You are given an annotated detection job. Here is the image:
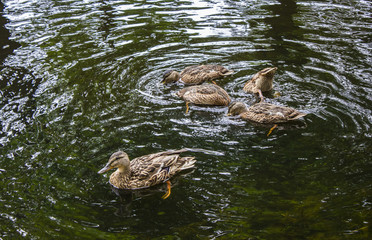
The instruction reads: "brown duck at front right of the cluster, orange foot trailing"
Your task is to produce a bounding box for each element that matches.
[227,102,307,136]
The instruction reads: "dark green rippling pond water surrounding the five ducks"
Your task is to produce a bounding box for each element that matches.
[0,0,372,239]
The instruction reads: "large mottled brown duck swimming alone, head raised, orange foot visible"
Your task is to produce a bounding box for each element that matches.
[98,149,196,199]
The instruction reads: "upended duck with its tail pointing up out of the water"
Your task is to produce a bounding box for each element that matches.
[243,67,278,102]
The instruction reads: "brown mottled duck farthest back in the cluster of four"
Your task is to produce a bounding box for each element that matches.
[162,65,234,85]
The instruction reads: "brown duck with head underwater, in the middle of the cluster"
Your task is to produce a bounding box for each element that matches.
[176,84,231,113]
